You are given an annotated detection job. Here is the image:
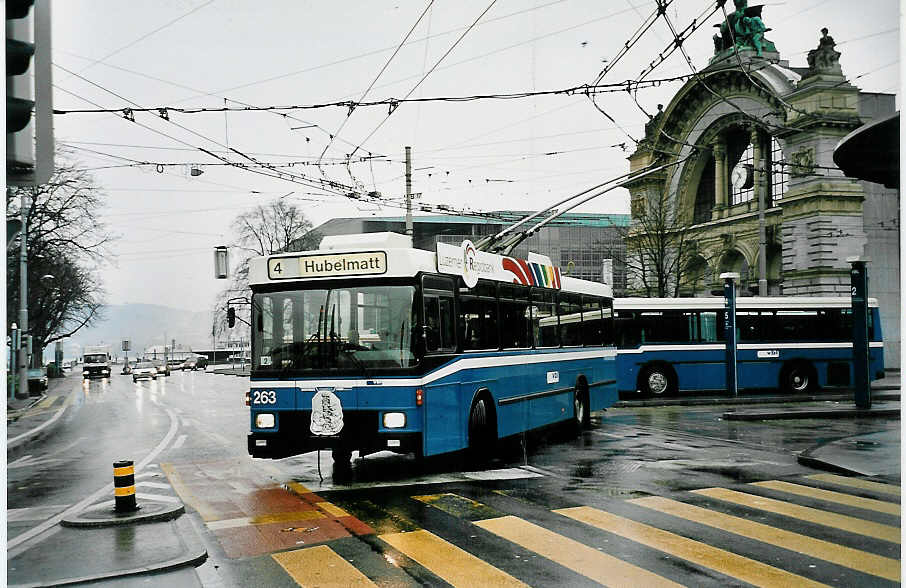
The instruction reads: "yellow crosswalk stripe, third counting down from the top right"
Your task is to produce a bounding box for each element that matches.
[692,488,900,543]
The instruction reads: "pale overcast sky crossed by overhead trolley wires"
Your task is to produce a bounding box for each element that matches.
[53,0,901,310]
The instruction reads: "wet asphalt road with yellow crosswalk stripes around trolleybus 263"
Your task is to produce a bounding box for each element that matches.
[7,372,900,586]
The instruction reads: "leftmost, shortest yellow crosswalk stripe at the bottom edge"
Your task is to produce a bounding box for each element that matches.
[271,545,377,588]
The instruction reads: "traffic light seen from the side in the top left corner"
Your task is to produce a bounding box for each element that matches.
[6,0,54,186]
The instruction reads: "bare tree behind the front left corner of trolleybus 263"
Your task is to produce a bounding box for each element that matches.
[213,199,321,336]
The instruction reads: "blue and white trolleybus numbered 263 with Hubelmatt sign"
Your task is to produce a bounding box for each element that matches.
[248,233,617,464]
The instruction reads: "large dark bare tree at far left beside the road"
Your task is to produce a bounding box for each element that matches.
[6,153,112,366]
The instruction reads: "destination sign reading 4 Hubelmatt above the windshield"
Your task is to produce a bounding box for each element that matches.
[267,251,387,280]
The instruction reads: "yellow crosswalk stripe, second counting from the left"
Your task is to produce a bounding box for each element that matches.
[380,530,526,588]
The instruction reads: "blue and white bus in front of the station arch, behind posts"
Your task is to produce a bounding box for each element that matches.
[614,296,884,397]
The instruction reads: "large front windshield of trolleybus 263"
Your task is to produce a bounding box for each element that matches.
[252,285,416,376]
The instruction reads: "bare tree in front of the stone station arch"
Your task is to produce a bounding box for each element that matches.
[623,190,697,297]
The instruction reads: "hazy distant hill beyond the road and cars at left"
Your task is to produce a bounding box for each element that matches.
[55,304,211,359]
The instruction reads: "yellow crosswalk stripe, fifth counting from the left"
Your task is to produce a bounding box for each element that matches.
[627,496,900,582]
